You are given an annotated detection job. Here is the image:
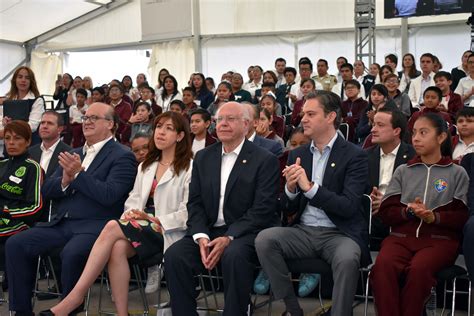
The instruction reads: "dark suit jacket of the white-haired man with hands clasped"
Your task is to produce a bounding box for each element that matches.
[187,140,280,238]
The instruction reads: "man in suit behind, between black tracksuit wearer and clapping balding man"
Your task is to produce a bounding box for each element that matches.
[29,111,71,222]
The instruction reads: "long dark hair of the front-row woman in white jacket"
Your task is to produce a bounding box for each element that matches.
[142,111,193,175]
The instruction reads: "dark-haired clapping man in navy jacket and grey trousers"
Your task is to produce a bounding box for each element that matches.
[255,91,370,316]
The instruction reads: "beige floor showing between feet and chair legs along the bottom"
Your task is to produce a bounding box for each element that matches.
[0,285,467,316]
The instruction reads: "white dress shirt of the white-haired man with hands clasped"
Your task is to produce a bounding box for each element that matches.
[193,138,245,243]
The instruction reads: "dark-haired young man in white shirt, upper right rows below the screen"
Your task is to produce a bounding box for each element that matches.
[408,53,435,108]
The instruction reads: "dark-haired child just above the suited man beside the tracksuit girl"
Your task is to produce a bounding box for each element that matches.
[356,83,388,142]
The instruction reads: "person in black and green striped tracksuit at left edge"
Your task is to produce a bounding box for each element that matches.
[0,121,44,280]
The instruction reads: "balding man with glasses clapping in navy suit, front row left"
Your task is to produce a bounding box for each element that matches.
[6,103,136,316]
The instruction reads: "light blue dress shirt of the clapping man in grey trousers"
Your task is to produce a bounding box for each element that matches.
[285,133,338,227]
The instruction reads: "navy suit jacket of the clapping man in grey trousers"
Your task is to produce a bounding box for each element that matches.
[285,135,370,266]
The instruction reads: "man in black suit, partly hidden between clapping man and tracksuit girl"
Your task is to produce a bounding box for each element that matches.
[367,108,415,250]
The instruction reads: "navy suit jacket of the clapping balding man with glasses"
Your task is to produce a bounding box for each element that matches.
[42,139,137,234]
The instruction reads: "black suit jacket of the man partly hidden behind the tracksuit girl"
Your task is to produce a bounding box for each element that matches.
[366,142,416,194]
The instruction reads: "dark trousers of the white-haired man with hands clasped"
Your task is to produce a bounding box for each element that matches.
[164,227,258,316]
